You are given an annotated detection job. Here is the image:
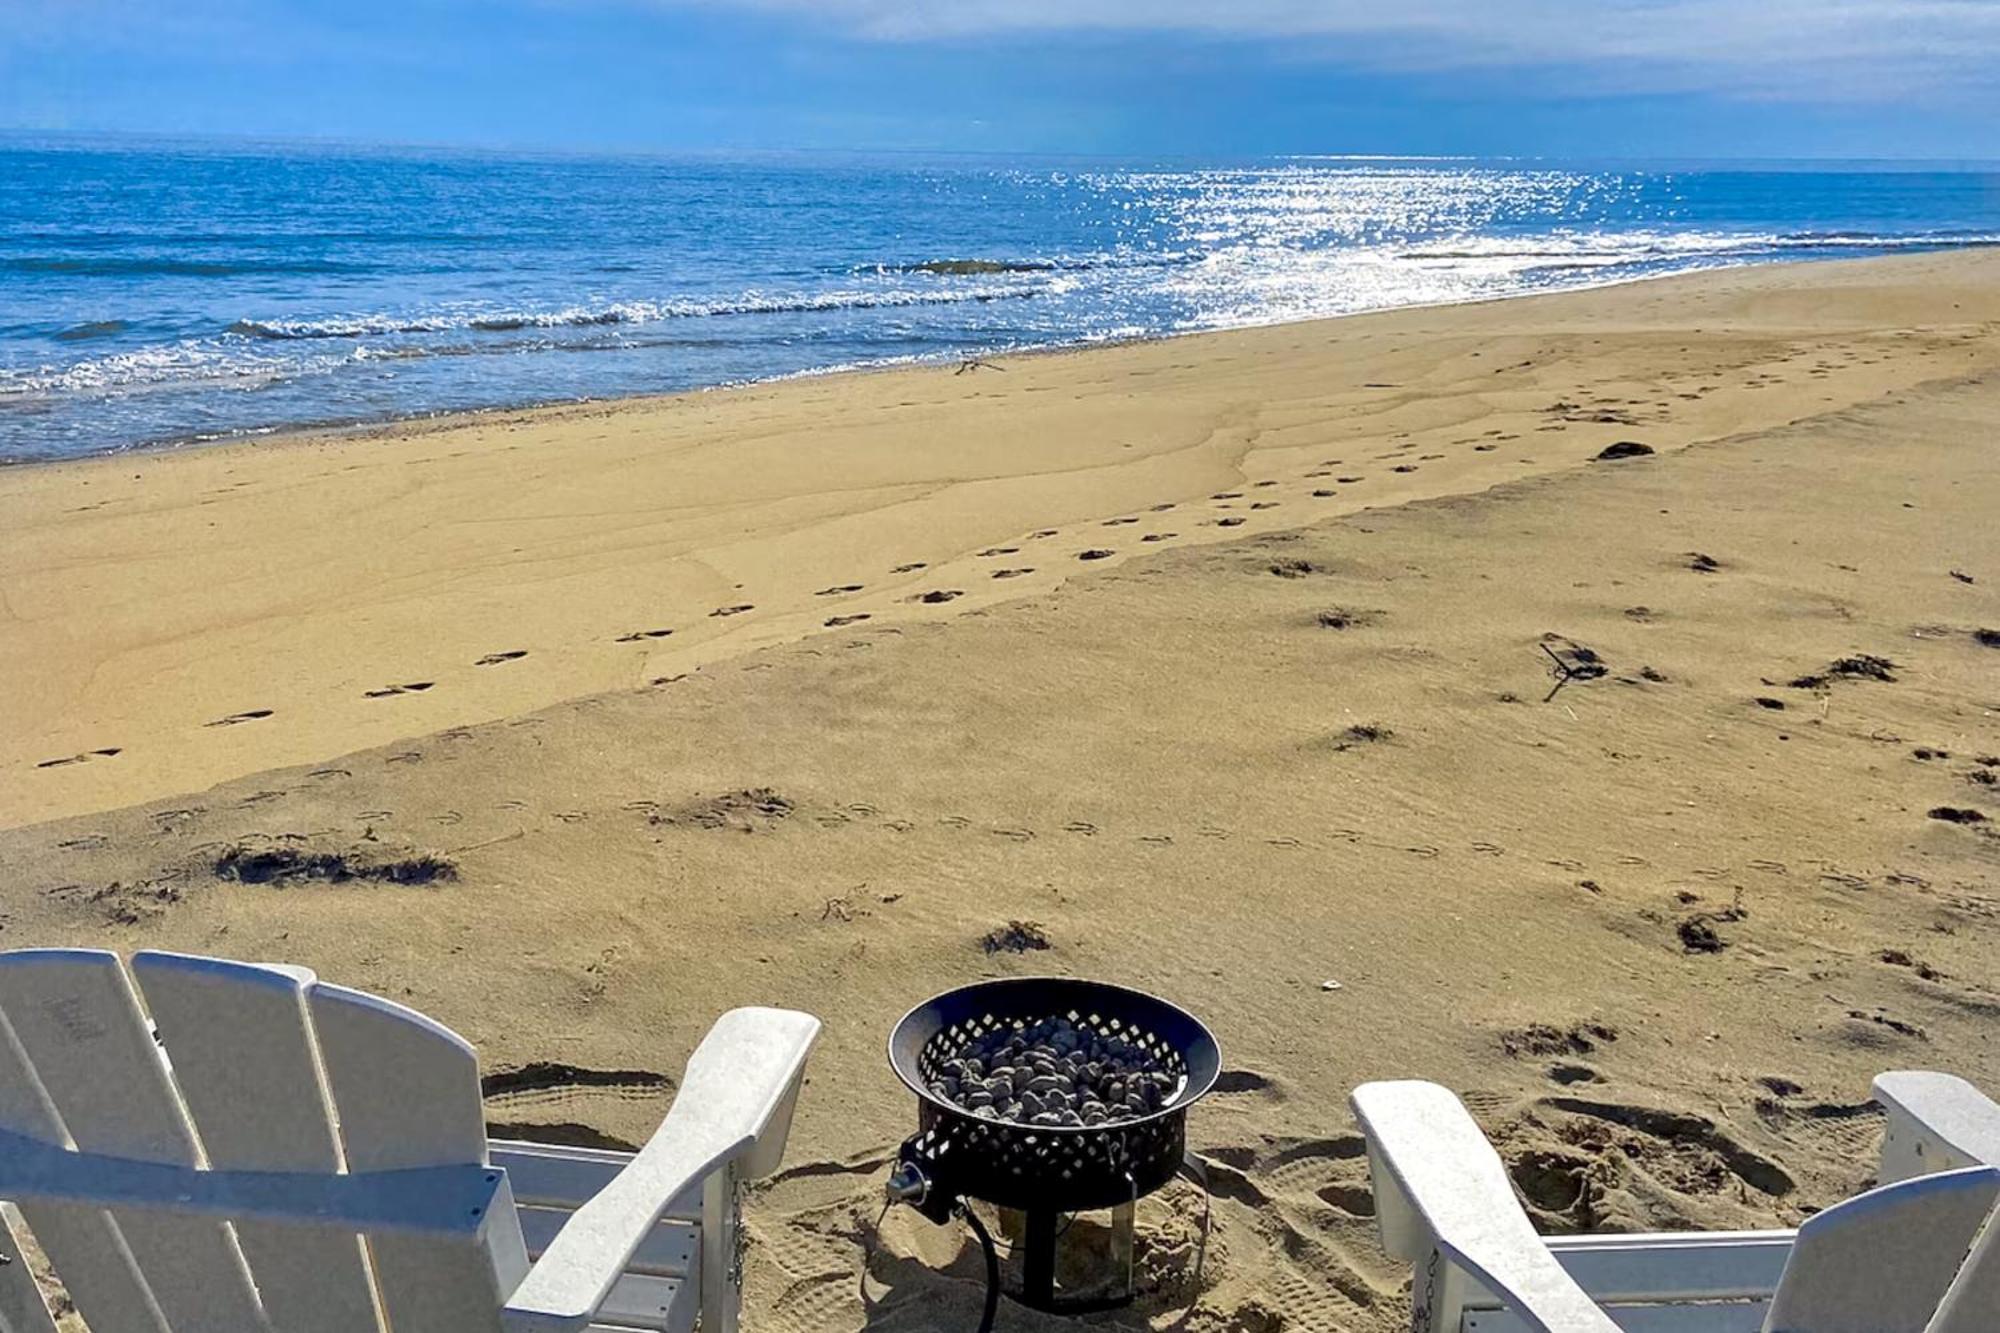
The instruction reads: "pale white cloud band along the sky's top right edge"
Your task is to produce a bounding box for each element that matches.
[666,0,2000,100]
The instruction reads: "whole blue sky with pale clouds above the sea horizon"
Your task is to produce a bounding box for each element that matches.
[0,0,2000,158]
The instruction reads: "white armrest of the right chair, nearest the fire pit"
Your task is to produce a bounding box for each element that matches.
[1352,1081,1618,1333]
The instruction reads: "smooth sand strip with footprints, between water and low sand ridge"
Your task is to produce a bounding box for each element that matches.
[0,250,2000,827]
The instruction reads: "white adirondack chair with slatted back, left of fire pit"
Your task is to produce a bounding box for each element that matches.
[0,949,820,1333]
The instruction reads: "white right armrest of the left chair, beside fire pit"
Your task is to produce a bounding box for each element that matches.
[502,1009,820,1333]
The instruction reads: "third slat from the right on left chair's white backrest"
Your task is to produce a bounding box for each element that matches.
[0,949,268,1333]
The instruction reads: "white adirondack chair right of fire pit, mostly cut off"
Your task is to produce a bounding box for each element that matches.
[1352,1073,2000,1333]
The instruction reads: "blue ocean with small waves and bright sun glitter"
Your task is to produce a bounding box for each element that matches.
[0,136,2000,462]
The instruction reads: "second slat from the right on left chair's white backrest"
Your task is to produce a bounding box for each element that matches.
[132,953,380,1333]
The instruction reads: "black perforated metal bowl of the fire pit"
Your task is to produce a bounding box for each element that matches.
[888,964,1222,1221]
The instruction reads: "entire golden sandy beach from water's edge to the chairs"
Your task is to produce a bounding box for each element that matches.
[0,254,2000,1333]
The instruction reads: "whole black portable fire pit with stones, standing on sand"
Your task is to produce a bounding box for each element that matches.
[888,977,1222,1323]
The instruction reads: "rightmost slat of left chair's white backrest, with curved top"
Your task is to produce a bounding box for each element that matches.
[310,985,528,1333]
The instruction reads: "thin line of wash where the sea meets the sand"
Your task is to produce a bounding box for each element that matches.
[0,240,2000,470]
